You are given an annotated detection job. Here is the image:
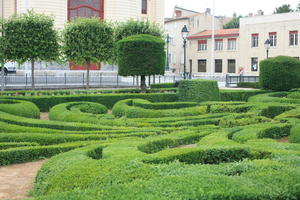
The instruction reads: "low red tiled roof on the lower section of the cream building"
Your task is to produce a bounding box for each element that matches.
[188,29,240,39]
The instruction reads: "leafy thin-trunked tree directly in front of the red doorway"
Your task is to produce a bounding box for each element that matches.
[63,18,114,88]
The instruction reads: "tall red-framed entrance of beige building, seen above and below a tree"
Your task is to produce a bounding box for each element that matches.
[68,0,104,70]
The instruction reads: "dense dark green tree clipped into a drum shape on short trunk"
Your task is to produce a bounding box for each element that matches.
[117,34,166,89]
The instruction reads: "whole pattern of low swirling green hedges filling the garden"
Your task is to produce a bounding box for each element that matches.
[0,82,300,200]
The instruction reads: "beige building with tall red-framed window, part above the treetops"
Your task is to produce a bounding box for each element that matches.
[0,0,164,28]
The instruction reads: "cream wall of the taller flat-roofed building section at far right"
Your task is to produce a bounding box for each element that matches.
[239,12,300,75]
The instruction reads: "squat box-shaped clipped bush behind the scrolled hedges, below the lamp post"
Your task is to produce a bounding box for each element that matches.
[178,79,220,102]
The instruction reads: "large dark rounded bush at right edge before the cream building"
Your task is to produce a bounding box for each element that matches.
[260,56,300,91]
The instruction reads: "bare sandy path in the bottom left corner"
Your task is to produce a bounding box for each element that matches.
[0,161,45,199]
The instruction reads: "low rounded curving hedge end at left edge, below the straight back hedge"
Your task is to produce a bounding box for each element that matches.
[0,99,40,119]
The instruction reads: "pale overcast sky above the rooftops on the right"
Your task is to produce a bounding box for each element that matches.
[165,0,300,17]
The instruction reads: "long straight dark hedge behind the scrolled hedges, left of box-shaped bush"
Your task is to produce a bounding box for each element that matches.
[2,93,178,112]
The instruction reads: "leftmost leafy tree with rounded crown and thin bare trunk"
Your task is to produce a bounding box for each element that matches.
[3,11,59,89]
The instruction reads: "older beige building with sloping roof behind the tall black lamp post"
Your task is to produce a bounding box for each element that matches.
[165,6,232,73]
